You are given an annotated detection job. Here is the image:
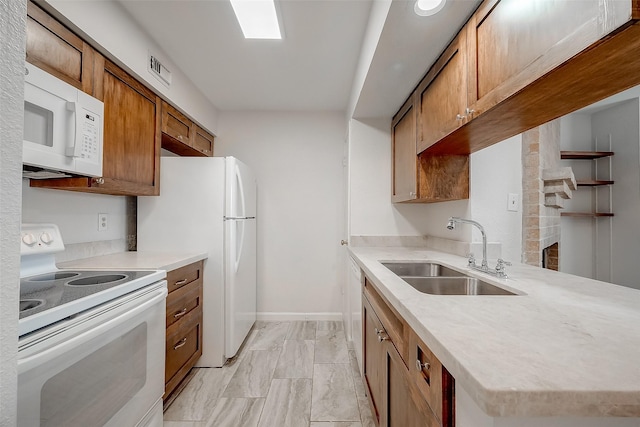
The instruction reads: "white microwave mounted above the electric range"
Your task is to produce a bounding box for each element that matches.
[22,63,104,179]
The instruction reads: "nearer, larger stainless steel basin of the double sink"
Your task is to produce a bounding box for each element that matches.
[402,277,516,295]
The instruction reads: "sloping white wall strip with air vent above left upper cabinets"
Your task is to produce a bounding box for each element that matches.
[47,0,218,134]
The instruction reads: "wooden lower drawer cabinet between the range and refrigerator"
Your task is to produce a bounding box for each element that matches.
[163,261,203,401]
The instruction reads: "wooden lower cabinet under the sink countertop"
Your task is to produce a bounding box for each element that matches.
[362,279,455,427]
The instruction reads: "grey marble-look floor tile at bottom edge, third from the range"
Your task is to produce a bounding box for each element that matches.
[259,378,312,427]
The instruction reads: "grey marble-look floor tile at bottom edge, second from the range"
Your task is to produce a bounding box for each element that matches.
[206,397,264,427]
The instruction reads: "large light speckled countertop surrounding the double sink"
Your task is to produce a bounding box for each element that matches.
[350,247,640,417]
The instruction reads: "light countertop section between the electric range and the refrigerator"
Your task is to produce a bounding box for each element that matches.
[57,252,207,271]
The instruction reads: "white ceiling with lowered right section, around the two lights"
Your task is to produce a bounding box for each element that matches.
[119,0,480,118]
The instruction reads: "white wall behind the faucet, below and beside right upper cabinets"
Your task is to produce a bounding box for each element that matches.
[349,119,522,262]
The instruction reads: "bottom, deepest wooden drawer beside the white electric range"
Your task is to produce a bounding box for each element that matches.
[164,310,202,390]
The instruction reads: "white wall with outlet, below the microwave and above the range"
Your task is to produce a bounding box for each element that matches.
[22,179,127,244]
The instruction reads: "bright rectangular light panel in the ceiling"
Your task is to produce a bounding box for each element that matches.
[230,0,282,39]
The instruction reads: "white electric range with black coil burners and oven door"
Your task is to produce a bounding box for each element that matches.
[18,224,167,427]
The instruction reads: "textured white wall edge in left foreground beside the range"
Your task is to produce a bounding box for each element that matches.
[0,0,27,426]
